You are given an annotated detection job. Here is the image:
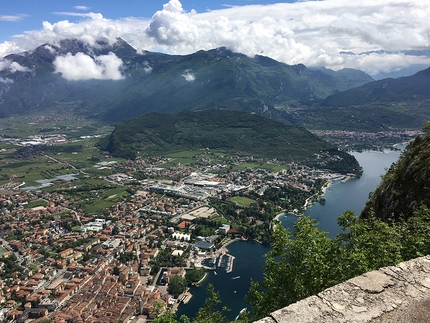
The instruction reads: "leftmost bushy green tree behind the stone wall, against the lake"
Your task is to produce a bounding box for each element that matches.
[247,216,336,318]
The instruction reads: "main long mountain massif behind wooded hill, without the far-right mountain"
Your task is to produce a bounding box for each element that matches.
[0,39,372,122]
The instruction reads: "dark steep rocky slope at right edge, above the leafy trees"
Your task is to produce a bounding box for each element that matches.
[361,130,430,221]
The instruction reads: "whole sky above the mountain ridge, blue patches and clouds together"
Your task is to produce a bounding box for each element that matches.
[0,0,430,77]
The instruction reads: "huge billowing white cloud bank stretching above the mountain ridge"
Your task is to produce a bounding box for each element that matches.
[0,0,430,73]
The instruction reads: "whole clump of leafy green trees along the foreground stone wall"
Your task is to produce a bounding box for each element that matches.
[247,207,430,319]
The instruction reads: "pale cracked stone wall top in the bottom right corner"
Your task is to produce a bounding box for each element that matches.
[258,256,430,323]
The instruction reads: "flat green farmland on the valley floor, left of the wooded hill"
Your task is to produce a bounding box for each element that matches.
[0,117,122,186]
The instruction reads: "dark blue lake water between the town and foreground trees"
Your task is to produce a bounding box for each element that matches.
[177,146,404,320]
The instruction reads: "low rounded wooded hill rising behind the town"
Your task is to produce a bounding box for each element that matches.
[100,109,360,173]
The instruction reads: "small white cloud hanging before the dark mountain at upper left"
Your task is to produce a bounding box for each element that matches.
[54,53,124,81]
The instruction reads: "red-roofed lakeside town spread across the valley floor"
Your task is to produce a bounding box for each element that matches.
[0,123,412,323]
